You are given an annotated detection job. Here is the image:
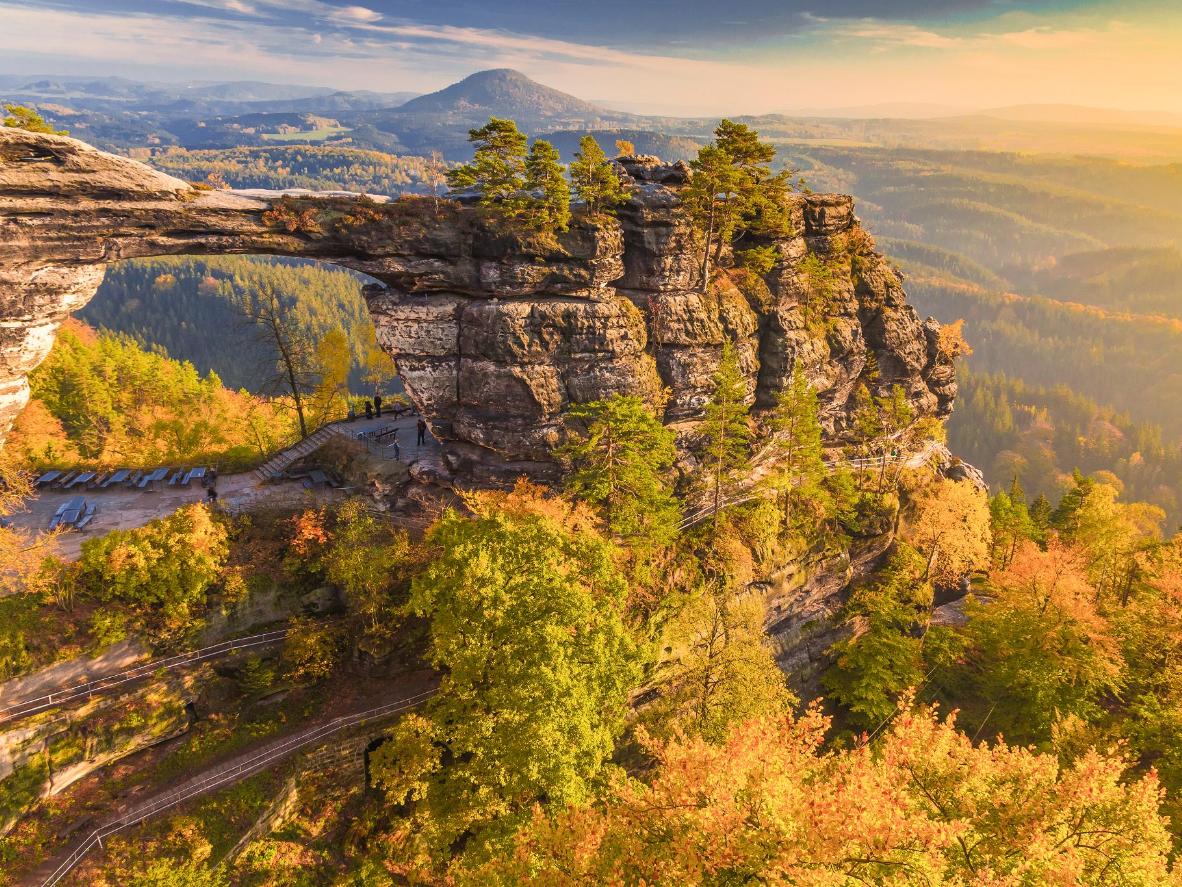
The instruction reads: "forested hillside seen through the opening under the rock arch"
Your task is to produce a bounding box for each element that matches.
[79,255,397,391]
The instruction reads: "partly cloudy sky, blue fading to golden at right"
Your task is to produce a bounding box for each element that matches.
[0,0,1182,115]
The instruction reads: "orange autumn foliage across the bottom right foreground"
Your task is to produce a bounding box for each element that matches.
[456,706,1178,887]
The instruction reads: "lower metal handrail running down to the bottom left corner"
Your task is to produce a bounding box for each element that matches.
[44,689,436,887]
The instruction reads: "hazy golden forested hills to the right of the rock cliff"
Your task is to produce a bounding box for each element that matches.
[782,144,1182,522]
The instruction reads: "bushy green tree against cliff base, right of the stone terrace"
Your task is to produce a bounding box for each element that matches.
[559,394,681,562]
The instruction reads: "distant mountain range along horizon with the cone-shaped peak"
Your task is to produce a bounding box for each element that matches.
[0,69,1182,162]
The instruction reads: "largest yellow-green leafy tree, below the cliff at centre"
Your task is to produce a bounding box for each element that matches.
[385,485,639,861]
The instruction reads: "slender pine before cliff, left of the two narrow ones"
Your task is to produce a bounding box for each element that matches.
[701,342,751,522]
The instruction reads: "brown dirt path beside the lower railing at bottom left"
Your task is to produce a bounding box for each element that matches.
[18,671,437,887]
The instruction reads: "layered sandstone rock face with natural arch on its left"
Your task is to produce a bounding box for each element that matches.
[0,128,956,484]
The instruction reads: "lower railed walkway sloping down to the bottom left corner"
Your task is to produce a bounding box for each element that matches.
[32,688,435,887]
